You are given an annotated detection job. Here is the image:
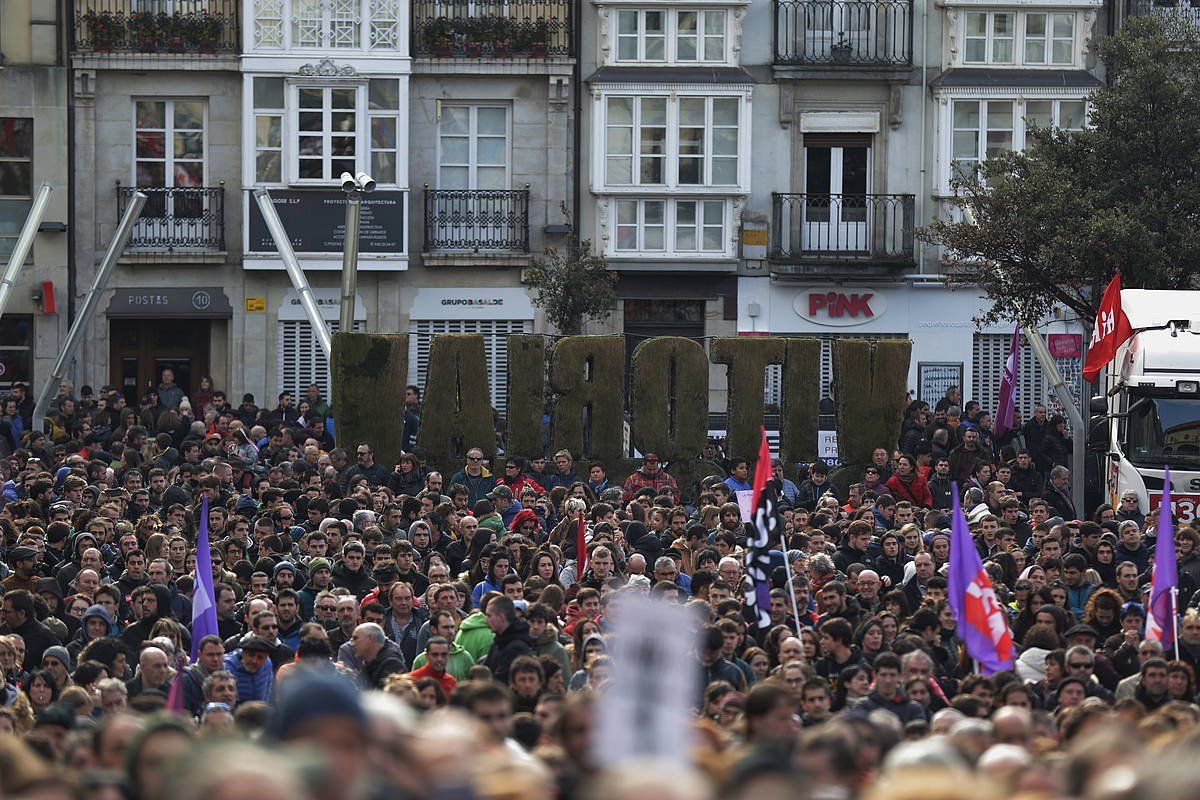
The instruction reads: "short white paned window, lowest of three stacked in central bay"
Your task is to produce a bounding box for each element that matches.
[613,199,728,255]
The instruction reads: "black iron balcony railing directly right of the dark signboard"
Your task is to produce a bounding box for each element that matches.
[425,185,529,253]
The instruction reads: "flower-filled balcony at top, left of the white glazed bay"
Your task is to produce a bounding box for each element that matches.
[71,0,240,55]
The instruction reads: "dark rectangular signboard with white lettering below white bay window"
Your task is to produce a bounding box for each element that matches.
[250,190,404,254]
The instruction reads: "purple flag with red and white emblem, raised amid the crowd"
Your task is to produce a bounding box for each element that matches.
[947,483,1013,675]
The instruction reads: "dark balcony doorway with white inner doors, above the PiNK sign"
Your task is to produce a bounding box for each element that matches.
[804,133,871,252]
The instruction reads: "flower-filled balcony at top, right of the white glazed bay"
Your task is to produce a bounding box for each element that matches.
[412,0,575,61]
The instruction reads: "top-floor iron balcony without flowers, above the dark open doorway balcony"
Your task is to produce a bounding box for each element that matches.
[774,0,912,71]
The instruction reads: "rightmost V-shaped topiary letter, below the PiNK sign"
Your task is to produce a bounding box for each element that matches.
[833,338,912,467]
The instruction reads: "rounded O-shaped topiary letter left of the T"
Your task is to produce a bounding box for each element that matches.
[630,336,708,486]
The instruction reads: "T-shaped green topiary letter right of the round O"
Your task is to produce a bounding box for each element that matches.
[712,337,785,461]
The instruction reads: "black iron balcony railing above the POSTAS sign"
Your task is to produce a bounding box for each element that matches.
[116,186,224,253]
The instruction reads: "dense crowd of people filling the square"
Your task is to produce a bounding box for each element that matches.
[0,369,1200,800]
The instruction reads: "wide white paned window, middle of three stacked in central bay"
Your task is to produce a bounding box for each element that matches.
[605,96,740,187]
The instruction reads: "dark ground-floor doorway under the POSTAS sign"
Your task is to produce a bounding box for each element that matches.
[108,319,212,405]
